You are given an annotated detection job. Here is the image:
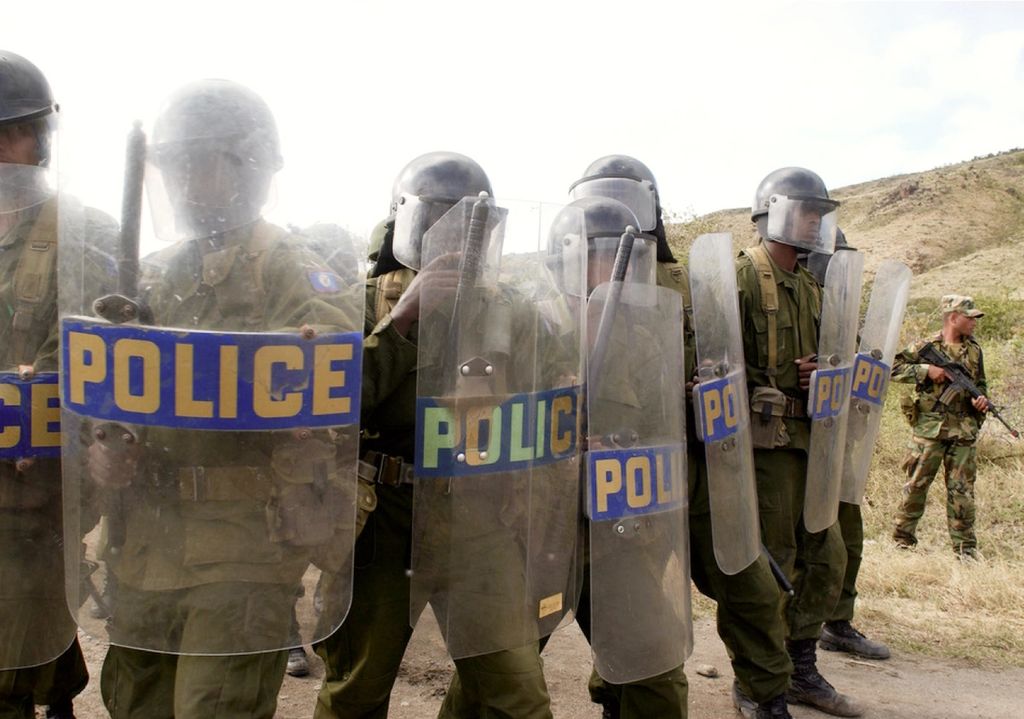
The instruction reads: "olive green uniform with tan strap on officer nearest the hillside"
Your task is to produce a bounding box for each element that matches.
[736,246,846,640]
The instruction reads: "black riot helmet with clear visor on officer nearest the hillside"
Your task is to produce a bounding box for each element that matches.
[751,167,839,255]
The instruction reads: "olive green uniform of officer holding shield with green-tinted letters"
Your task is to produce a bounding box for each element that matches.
[314,269,551,719]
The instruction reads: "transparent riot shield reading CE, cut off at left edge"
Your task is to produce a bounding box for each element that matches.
[0,163,75,670]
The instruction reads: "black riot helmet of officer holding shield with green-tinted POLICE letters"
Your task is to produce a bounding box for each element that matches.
[387,152,492,271]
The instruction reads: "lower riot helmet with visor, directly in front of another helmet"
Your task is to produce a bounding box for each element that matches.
[548,196,656,297]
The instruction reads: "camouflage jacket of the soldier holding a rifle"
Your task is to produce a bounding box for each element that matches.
[892,333,988,443]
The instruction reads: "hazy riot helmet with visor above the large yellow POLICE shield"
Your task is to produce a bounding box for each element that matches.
[146,80,283,240]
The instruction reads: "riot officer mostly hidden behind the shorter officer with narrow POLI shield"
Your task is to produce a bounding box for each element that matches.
[570,155,793,719]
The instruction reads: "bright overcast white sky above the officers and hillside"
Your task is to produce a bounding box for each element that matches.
[3,0,1024,240]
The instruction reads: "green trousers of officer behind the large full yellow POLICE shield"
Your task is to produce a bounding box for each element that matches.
[99,582,295,719]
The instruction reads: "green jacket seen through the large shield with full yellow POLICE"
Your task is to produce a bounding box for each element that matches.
[115,220,358,591]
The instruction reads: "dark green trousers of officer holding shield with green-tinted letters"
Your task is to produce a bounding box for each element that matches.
[313,484,551,719]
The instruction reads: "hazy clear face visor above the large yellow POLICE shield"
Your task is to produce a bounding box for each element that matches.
[145,141,273,242]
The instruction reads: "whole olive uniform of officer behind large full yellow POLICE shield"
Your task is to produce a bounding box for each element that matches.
[101,220,357,719]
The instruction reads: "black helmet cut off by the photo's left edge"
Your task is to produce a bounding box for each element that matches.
[0,50,59,165]
